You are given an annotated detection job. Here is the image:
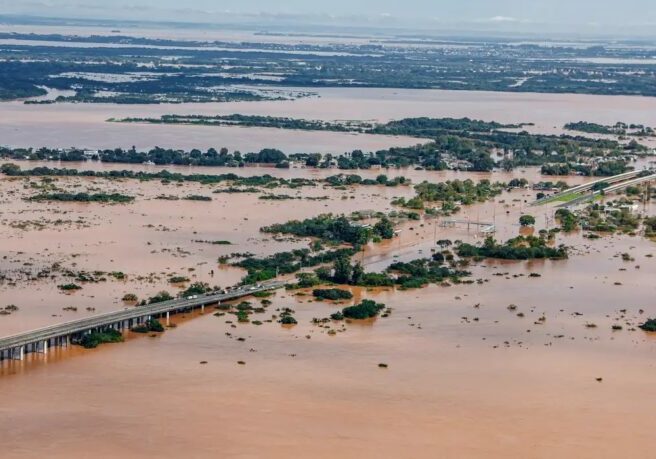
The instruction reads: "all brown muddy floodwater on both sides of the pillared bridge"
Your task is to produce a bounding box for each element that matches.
[0,163,656,458]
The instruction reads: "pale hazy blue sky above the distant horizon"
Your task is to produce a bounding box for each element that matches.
[0,0,656,36]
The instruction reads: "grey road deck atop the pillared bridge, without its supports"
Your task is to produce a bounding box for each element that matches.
[0,282,285,352]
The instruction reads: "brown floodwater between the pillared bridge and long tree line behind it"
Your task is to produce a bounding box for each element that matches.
[0,162,560,335]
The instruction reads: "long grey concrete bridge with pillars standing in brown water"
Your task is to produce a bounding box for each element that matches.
[0,281,285,360]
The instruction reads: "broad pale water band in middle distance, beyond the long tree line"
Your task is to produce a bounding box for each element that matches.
[0,88,656,154]
